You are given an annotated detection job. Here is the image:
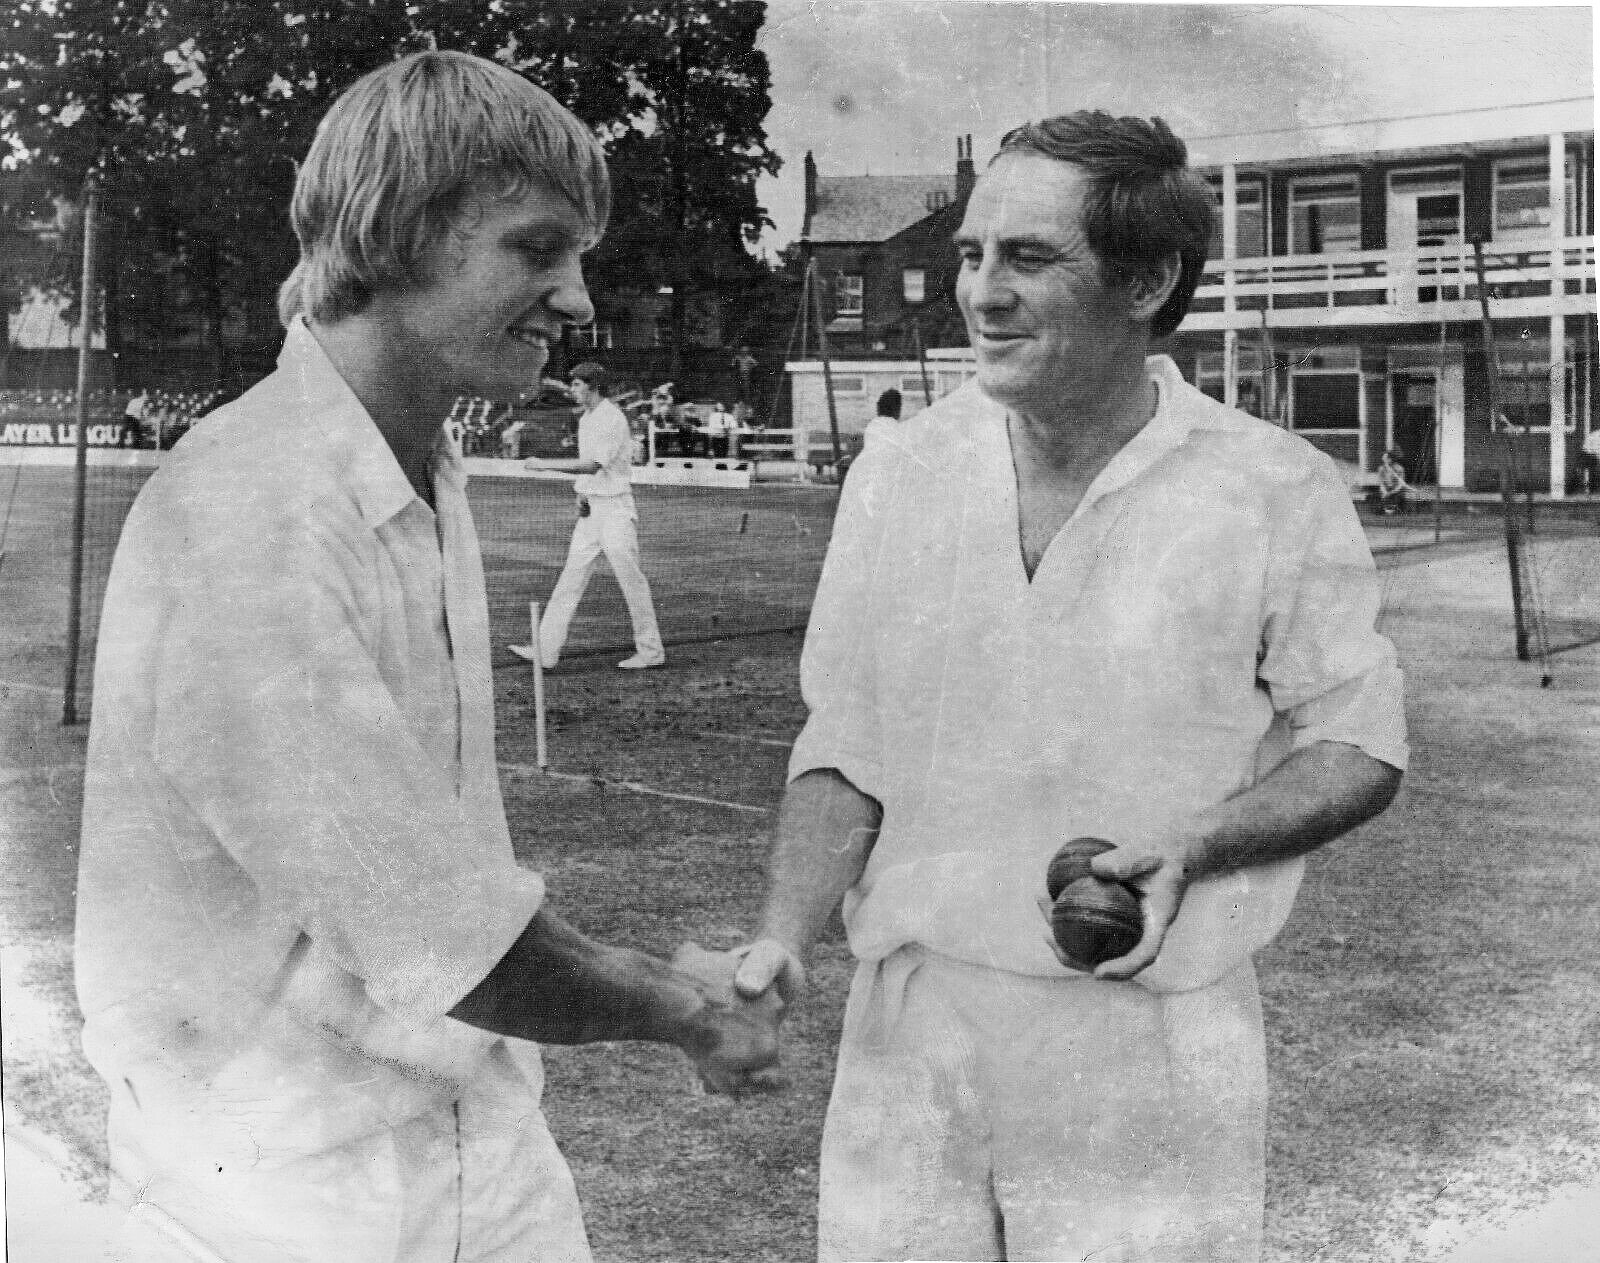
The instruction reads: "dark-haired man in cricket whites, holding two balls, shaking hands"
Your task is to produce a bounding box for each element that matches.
[725,112,1406,1263]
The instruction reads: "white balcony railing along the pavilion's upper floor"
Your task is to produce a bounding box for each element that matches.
[1192,237,1595,327]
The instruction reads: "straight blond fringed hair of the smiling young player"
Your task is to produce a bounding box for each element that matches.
[278,51,611,325]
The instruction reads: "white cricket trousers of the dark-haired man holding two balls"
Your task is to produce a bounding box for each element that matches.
[818,948,1266,1263]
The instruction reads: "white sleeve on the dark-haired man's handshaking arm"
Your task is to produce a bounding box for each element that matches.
[789,451,896,800]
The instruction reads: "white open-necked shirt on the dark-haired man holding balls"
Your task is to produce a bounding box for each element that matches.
[789,357,1406,989]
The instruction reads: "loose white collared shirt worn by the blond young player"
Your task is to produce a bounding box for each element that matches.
[77,322,544,1149]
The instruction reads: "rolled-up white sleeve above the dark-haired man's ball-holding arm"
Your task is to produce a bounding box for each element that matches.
[1258,464,1410,770]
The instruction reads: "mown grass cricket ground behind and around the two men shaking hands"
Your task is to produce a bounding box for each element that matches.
[0,469,1600,1263]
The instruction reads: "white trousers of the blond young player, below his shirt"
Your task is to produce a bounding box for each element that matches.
[104,1043,592,1263]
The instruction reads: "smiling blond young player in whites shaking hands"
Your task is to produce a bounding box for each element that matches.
[77,53,778,1263]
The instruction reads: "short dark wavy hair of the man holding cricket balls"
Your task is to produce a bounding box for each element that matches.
[989,110,1216,338]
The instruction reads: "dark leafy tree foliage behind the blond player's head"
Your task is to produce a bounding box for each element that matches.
[0,0,778,369]
